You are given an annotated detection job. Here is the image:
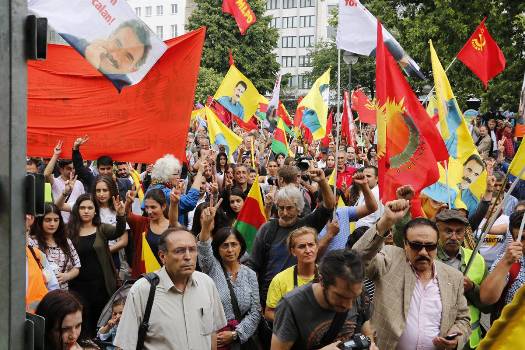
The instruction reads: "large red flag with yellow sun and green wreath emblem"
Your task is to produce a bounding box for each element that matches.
[376,21,448,202]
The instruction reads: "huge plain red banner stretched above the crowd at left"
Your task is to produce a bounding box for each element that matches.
[27,28,205,163]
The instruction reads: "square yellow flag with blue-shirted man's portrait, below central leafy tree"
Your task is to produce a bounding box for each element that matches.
[213,64,261,121]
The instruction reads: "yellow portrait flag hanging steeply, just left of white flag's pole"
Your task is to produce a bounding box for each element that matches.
[297,68,330,140]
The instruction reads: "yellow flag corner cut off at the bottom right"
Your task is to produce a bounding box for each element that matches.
[478,287,525,350]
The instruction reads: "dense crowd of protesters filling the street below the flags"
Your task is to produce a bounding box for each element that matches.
[26,108,525,350]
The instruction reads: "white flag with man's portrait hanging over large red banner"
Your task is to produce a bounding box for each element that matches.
[28,0,167,91]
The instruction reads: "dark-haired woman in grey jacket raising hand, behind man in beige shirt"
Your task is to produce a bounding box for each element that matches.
[197,198,261,350]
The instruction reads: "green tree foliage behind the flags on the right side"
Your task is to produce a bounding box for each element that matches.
[312,0,525,112]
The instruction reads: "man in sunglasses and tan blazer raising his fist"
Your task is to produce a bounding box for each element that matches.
[354,199,471,350]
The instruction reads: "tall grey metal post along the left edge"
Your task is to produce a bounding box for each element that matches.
[0,0,27,350]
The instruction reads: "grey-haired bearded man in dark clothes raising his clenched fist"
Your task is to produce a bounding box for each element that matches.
[248,169,336,310]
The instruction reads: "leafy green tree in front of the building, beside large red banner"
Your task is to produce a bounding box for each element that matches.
[187,0,279,102]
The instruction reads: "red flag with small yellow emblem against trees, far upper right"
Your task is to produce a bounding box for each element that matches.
[458,18,506,88]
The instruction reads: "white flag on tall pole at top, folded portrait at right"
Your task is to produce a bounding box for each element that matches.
[336,0,425,79]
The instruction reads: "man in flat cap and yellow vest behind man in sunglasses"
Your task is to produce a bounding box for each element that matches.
[436,209,488,349]
